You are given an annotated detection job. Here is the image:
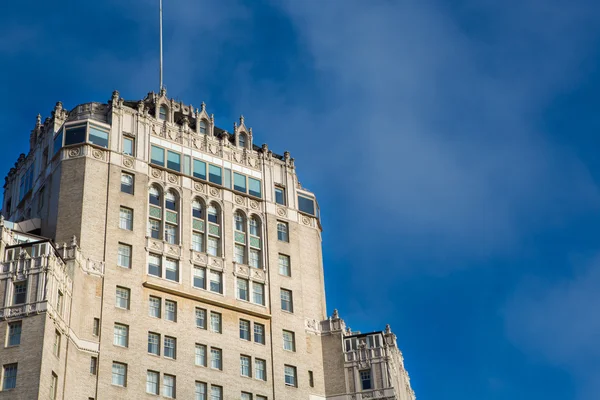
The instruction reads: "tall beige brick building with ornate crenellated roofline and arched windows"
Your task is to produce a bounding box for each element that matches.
[0,90,414,400]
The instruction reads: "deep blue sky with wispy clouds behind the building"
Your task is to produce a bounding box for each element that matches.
[0,0,600,400]
